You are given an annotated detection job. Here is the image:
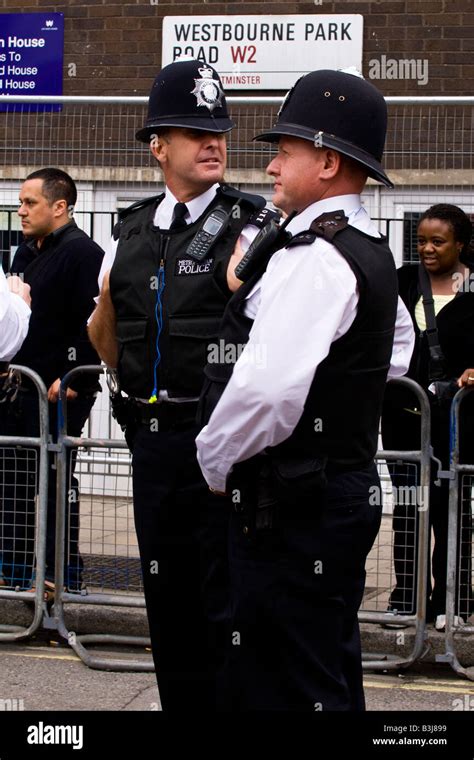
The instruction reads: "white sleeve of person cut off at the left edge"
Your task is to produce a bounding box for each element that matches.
[0,267,31,362]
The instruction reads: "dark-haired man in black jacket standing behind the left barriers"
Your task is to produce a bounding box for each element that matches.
[0,168,103,590]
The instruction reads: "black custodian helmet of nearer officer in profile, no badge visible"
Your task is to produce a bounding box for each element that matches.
[254,69,393,187]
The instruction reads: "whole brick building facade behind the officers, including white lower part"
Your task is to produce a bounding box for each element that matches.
[0,0,474,262]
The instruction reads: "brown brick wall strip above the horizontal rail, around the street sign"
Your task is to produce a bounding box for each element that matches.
[0,0,474,95]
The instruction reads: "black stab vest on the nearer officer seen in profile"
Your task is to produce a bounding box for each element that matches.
[199,212,398,469]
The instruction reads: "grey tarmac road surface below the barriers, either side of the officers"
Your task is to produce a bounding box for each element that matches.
[0,633,474,712]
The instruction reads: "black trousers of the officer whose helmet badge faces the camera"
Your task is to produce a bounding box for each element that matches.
[133,424,229,713]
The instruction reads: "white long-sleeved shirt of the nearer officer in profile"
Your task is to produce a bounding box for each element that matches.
[196,195,414,491]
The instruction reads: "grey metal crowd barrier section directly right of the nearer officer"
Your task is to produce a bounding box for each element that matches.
[359,378,431,670]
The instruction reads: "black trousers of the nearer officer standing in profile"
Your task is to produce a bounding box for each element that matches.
[221,465,381,712]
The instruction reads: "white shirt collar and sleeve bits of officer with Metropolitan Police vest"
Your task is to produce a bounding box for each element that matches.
[95,183,259,290]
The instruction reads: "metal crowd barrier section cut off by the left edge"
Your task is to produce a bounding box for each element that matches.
[0,364,49,641]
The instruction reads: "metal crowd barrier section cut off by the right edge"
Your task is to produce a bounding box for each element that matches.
[437,388,474,681]
